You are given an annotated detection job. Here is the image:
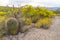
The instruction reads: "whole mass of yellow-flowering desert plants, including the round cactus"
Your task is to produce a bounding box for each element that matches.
[0,5,56,36]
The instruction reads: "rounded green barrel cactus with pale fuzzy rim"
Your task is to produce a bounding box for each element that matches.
[6,18,18,35]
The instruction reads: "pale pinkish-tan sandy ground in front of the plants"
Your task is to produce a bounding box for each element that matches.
[1,16,60,40]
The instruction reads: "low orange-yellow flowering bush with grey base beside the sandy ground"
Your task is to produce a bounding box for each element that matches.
[35,18,51,29]
